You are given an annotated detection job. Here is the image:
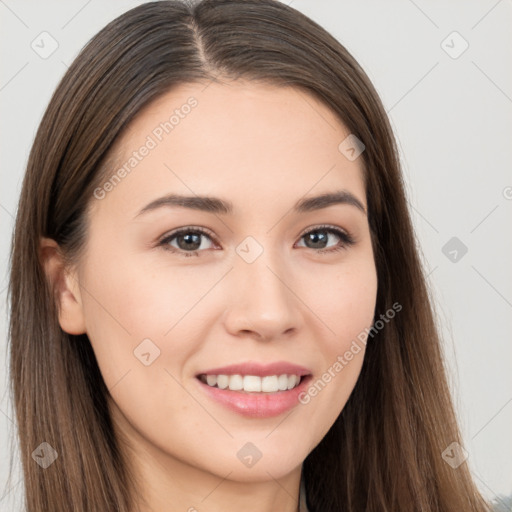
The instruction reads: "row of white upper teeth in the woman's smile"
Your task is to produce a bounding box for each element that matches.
[201,374,300,393]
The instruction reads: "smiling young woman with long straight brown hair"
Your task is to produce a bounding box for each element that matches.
[5,0,488,512]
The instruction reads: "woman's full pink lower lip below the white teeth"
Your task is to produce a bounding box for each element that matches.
[196,375,312,418]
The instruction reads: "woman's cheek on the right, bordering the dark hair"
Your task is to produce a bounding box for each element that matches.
[294,258,377,435]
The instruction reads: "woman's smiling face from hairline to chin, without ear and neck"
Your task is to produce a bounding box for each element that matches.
[61,81,377,482]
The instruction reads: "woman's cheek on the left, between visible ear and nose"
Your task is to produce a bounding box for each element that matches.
[77,245,225,387]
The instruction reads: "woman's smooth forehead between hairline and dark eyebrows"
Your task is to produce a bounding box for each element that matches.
[91,81,364,221]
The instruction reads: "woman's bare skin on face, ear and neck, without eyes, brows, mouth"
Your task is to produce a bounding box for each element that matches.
[41,81,377,512]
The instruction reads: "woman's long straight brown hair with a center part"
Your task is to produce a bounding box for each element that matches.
[5,0,488,512]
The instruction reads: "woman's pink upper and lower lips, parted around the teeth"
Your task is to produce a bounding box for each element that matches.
[197,362,312,418]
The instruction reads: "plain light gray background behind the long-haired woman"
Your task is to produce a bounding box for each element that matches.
[0,0,512,511]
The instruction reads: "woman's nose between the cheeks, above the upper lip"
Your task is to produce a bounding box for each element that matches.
[224,252,303,340]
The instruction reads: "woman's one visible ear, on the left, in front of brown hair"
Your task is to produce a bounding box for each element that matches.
[39,238,86,334]
